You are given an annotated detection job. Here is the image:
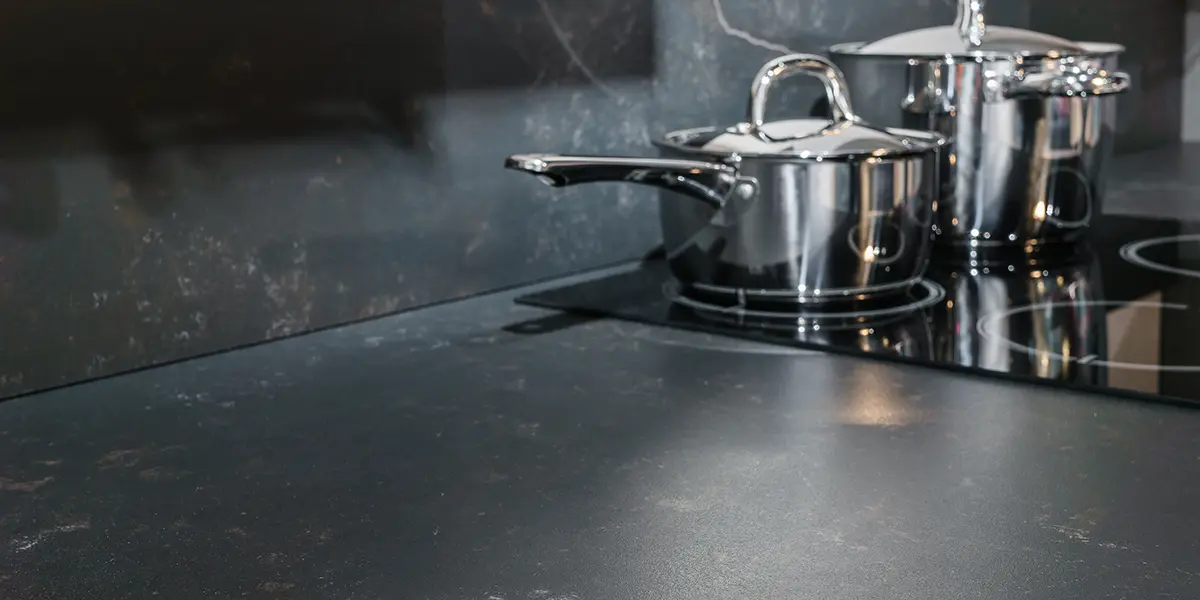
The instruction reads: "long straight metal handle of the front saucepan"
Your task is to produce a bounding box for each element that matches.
[504,154,756,209]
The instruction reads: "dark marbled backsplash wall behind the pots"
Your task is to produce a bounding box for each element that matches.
[0,0,1183,396]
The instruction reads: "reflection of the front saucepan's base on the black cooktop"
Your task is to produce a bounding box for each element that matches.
[667,281,944,360]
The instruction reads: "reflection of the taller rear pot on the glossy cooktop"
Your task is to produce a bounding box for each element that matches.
[929,246,1106,385]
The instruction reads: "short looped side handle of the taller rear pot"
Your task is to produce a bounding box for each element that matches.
[1003,59,1129,98]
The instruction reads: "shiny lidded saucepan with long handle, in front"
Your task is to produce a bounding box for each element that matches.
[505,54,944,302]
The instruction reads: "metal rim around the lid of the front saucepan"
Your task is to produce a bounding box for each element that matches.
[650,126,949,163]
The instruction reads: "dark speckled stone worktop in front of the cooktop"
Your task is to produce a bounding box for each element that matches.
[0,267,1200,600]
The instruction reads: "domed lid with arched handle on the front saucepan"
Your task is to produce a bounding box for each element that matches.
[667,54,944,160]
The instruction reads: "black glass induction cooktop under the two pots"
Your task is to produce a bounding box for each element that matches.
[517,216,1200,404]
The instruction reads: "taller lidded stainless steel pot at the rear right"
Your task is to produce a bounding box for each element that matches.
[829,0,1129,248]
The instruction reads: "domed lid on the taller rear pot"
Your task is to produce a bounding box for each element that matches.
[854,0,1087,56]
